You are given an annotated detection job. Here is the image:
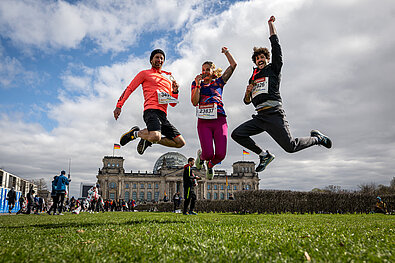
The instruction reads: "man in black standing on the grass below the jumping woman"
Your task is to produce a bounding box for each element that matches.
[183,157,201,215]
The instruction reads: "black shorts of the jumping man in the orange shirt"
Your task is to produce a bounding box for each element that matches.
[143,109,181,139]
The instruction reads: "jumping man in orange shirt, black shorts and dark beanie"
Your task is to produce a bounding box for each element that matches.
[114,49,185,154]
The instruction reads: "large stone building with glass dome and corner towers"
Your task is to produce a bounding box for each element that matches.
[97,152,259,202]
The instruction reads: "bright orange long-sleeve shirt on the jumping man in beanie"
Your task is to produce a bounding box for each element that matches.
[117,68,178,114]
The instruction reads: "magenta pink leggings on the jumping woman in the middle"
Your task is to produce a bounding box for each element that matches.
[197,115,228,166]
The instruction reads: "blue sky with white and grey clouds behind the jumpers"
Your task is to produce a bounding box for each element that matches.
[0,0,395,198]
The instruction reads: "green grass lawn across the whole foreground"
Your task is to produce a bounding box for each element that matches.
[0,212,395,262]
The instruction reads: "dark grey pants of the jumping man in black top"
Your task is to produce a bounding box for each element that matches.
[231,107,318,154]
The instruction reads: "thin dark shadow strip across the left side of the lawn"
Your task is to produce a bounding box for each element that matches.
[0,219,186,229]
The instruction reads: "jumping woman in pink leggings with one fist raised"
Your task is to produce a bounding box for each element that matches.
[191,47,237,180]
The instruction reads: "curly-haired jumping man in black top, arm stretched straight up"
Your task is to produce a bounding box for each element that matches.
[232,16,332,172]
